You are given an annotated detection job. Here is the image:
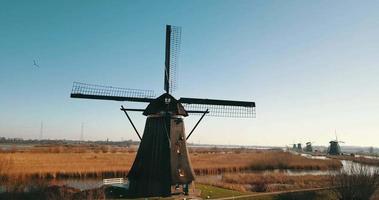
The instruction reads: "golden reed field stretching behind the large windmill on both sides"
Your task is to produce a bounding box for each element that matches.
[0,147,341,178]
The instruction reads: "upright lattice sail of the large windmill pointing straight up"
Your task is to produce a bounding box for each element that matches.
[164,25,182,93]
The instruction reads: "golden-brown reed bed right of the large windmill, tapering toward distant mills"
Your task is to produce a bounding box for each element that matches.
[191,151,342,175]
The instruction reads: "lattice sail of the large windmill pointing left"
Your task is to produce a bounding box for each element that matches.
[71,82,155,103]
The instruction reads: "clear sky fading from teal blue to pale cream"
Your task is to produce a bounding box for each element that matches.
[0,0,379,146]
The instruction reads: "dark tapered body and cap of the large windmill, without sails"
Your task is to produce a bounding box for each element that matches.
[128,93,195,197]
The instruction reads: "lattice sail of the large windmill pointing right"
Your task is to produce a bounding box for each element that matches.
[179,98,255,118]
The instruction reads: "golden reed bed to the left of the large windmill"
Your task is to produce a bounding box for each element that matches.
[0,152,135,178]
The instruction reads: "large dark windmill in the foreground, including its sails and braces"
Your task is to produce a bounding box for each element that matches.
[71,25,255,197]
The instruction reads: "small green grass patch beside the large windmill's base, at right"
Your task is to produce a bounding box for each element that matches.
[195,183,250,199]
